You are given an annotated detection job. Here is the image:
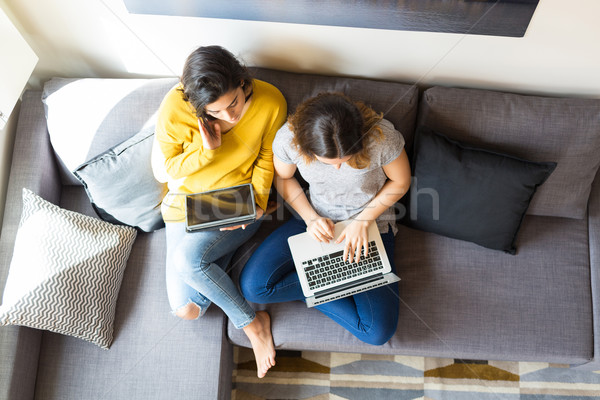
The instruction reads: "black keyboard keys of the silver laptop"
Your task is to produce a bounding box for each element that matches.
[302,241,383,290]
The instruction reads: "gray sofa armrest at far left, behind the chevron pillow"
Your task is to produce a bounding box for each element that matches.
[0,91,62,399]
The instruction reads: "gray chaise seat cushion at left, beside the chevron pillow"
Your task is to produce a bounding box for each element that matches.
[32,186,233,400]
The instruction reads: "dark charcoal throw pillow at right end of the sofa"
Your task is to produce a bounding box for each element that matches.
[409,127,556,254]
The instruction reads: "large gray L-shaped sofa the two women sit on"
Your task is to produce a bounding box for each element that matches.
[0,69,600,399]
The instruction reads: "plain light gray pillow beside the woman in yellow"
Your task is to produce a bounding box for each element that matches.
[73,126,168,232]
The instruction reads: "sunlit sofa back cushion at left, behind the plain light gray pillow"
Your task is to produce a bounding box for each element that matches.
[42,78,178,185]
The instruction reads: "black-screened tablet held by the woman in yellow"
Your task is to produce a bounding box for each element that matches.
[185,183,256,232]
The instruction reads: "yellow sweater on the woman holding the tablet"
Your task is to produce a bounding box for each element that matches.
[156,79,287,222]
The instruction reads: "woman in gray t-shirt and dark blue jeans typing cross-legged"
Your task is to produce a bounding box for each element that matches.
[240,93,411,345]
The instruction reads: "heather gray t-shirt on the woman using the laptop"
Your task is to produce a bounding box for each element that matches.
[273,120,404,235]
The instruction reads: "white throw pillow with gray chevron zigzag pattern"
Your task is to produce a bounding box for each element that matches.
[0,189,137,349]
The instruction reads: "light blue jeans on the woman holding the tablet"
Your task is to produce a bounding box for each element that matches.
[166,220,261,329]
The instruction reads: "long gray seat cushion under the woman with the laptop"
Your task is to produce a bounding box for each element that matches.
[228,216,594,364]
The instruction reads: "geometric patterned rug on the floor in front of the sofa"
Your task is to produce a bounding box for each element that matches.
[231,347,600,400]
